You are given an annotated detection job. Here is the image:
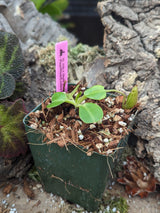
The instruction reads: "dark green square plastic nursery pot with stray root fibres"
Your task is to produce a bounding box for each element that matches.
[23,98,134,211]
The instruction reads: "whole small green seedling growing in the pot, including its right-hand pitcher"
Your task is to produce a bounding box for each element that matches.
[47,85,138,123]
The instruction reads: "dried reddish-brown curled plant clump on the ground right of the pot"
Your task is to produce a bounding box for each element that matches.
[117,156,160,198]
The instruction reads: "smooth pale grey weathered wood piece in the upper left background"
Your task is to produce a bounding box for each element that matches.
[0,0,76,52]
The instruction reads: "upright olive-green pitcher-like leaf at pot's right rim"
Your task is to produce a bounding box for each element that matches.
[122,86,138,109]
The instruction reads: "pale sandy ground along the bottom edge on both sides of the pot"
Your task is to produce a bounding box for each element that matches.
[0,181,160,213]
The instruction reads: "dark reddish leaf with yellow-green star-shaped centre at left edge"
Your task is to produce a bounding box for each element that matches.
[0,99,28,158]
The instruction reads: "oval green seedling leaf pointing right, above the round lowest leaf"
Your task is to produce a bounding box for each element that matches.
[84,85,106,100]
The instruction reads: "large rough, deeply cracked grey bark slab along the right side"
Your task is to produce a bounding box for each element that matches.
[97,0,160,181]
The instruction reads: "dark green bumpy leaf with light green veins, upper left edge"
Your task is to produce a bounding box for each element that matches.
[0,32,24,99]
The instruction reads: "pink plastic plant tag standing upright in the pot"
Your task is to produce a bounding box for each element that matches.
[55,41,68,92]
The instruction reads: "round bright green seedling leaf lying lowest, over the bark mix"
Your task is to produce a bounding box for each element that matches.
[79,103,103,123]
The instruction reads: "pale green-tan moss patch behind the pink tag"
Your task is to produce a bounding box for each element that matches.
[37,43,105,80]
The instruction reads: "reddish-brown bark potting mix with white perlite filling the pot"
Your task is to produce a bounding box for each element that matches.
[29,86,138,156]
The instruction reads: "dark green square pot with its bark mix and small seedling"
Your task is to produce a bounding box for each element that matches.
[24,84,138,211]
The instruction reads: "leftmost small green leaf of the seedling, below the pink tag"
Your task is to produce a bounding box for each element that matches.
[47,92,68,108]
